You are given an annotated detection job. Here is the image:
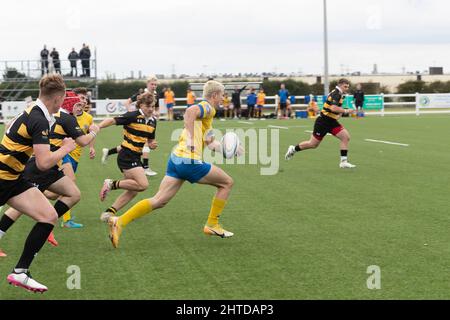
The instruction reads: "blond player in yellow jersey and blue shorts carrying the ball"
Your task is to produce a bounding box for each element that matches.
[108,80,239,248]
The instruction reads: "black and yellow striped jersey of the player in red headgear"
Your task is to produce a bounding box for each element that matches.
[50,111,84,151]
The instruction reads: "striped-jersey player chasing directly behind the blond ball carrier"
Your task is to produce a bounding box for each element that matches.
[99,92,158,220]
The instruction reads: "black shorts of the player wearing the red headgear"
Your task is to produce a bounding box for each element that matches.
[23,158,65,192]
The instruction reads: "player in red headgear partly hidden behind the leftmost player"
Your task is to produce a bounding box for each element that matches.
[2,91,99,246]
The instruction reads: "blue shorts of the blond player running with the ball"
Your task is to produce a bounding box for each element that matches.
[166,154,212,183]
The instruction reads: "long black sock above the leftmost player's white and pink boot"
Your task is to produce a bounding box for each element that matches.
[16,222,53,270]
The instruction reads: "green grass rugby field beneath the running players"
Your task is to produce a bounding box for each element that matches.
[0,115,450,300]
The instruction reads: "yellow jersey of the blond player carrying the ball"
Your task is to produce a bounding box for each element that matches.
[173,101,216,160]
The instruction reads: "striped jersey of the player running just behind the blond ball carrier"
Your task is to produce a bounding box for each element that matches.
[114,110,157,154]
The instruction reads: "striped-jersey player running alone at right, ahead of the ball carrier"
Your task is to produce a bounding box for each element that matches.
[285,79,356,169]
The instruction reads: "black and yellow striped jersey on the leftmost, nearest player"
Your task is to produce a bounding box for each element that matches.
[0,105,50,180]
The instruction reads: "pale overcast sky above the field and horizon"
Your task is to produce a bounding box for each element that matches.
[0,0,450,77]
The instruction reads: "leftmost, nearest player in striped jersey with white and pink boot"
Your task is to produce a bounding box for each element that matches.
[0,75,75,292]
